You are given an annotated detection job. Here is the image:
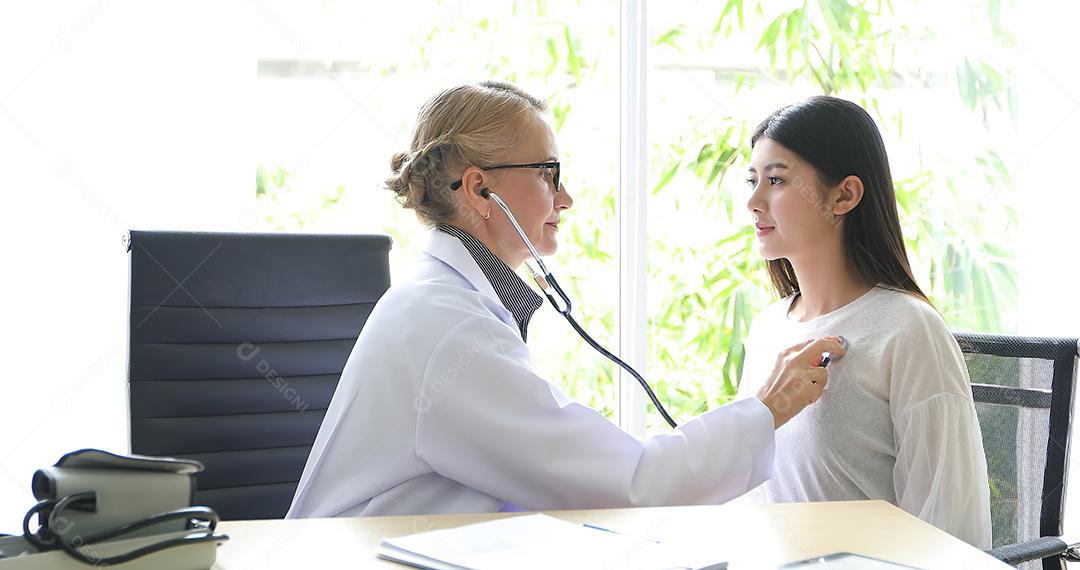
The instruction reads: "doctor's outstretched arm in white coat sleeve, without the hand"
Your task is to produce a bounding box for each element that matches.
[417,316,833,510]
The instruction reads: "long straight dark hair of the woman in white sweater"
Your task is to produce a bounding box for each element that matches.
[751,96,930,303]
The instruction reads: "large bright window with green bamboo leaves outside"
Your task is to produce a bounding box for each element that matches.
[255,0,1071,433]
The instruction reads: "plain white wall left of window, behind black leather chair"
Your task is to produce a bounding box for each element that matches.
[0,1,255,524]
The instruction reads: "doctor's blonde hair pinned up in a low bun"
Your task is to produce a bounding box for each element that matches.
[386,81,546,226]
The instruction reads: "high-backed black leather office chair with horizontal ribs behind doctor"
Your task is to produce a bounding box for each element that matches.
[127,231,390,519]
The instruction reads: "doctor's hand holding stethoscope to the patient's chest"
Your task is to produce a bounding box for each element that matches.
[757,337,847,428]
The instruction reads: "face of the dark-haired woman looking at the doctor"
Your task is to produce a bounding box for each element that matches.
[746,138,840,260]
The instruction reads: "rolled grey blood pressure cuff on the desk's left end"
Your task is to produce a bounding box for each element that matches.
[31,449,203,537]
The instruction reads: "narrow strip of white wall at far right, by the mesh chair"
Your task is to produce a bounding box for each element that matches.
[1016,0,1080,542]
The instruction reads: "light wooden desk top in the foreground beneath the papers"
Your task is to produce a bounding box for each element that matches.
[214,501,1010,570]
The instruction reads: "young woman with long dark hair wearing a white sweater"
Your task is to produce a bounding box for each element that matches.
[739,97,990,548]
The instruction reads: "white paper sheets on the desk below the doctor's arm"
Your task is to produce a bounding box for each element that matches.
[376,514,723,570]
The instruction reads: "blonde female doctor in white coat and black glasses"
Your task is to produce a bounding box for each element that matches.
[287,82,843,518]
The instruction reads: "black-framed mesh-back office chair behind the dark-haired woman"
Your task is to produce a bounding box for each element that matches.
[956,333,1078,570]
